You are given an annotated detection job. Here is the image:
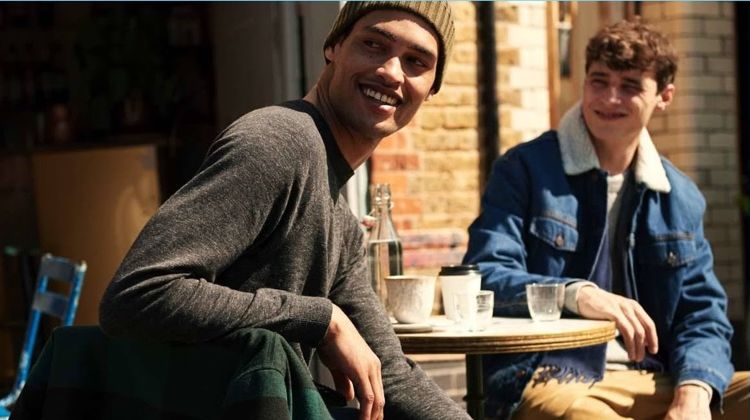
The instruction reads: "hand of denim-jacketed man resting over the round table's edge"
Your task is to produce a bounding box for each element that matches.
[578,287,659,362]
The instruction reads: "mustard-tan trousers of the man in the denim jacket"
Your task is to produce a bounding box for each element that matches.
[513,370,750,420]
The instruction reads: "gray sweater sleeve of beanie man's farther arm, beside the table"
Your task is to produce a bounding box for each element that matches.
[331,217,469,420]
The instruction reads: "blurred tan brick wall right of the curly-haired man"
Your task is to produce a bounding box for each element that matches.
[642,2,745,320]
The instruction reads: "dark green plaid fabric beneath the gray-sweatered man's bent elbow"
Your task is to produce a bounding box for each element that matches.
[11,326,330,420]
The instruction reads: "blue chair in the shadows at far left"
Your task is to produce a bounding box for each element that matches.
[0,254,86,420]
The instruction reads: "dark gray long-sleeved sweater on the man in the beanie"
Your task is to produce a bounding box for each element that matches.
[100,100,466,419]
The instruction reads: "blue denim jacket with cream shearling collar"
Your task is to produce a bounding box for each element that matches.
[464,105,734,418]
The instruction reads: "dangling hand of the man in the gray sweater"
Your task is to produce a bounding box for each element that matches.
[318,305,385,420]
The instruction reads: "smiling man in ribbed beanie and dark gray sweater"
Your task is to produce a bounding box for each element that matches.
[100,1,468,419]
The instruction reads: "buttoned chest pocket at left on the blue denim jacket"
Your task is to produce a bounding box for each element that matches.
[527,216,578,276]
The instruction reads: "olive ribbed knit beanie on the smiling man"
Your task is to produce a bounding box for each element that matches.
[323,0,456,93]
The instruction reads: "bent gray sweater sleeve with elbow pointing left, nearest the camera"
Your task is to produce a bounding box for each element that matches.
[100,130,332,346]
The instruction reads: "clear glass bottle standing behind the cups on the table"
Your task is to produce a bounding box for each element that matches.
[367,184,403,305]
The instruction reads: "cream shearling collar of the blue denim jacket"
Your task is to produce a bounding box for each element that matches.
[557,102,672,193]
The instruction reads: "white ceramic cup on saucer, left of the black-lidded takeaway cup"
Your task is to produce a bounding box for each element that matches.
[385,275,435,324]
